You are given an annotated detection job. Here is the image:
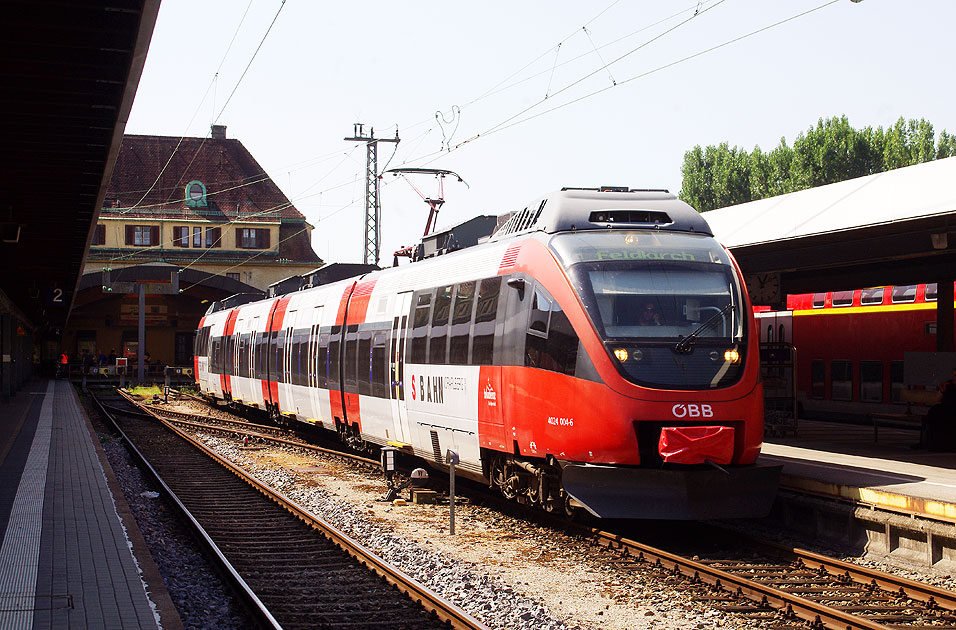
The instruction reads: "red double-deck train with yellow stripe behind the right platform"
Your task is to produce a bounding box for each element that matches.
[757,284,948,418]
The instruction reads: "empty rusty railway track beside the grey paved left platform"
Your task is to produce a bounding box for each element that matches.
[94,392,484,629]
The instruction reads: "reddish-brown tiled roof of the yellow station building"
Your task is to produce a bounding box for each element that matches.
[100,135,305,223]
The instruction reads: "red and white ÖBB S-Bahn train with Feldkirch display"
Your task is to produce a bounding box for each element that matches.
[195,188,779,519]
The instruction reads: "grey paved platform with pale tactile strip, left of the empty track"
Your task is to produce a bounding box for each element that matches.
[0,380,182,630]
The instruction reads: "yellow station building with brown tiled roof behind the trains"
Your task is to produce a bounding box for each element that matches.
[62,125,322,365]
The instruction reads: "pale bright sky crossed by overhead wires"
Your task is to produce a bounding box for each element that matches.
[126,0,956,265]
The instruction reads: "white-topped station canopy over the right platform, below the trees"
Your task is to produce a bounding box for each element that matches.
[703,157,956,295]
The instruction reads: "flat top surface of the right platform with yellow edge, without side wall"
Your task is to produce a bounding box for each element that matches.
[760,420,956,522]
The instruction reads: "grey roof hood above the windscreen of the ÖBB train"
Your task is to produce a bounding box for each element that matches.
[489,186,713,241]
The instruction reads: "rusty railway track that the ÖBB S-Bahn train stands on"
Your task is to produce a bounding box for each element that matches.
[127,396,956,630]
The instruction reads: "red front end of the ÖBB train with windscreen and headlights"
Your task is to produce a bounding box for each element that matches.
[508,193,780,520]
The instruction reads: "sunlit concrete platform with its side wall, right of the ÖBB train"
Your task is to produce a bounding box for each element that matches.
[760,420,956,572]
